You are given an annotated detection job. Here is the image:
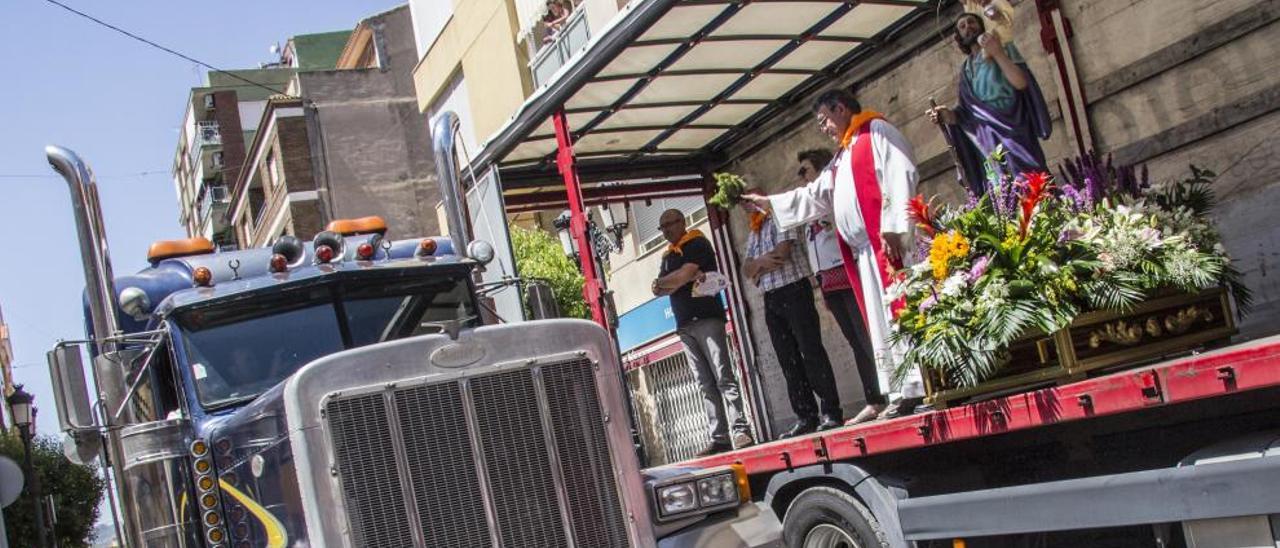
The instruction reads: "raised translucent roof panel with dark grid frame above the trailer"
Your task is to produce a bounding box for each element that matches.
[474,0,943,195]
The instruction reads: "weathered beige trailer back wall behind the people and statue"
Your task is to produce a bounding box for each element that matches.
[722,0,1280,426]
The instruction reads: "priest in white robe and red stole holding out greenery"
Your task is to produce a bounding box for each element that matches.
[742,90,924,423]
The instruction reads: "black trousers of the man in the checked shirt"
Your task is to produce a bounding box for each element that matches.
[764,279,844,421]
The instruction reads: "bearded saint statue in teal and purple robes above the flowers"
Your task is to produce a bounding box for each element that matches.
[927,4,1052,196]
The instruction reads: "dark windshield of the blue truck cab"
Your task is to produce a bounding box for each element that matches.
[177,278,475,408]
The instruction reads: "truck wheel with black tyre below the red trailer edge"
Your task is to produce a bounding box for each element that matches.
[782,487,888,548]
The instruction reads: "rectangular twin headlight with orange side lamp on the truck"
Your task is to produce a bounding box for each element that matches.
[652,465,751,521]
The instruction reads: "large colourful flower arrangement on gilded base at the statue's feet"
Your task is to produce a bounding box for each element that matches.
[890,151,1249,403]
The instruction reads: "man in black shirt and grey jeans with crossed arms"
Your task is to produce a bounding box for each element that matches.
[653,210,755,456]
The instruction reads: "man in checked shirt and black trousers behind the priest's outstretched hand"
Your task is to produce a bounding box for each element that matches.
[741,189,844,438]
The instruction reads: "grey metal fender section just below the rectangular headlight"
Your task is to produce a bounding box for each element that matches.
[658,502,783,548]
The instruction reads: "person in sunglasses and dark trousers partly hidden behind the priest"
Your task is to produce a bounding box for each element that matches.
[796,149,888,424]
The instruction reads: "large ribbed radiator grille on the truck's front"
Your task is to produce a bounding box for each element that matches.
[324,359,628,548]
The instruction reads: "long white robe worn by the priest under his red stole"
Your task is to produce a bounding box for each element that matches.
[769,119,924,401]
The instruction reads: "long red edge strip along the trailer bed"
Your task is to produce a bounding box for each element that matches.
[677,338,1280,474]
